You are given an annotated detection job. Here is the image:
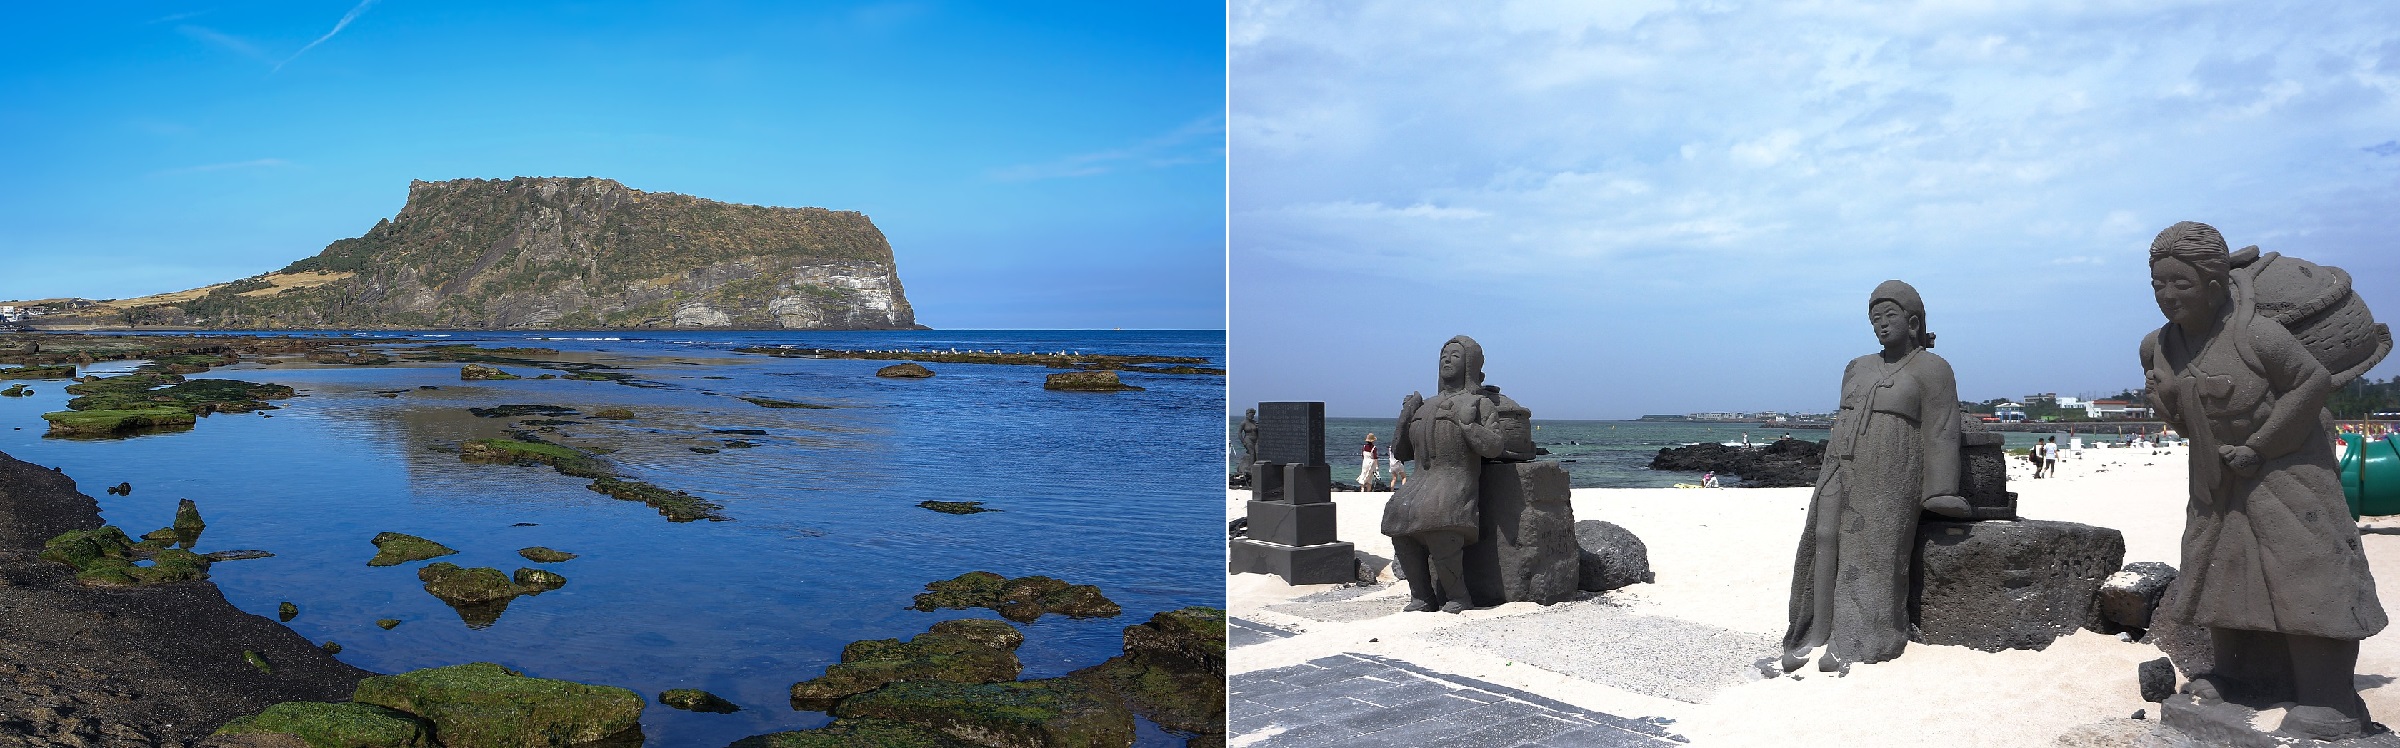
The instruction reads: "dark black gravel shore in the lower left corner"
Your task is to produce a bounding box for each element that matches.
[0,445,372,746]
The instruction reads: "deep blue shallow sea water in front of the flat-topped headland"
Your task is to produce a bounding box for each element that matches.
[0,331,1224,746]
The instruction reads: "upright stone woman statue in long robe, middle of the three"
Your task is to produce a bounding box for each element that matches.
[1783,281,1970,671]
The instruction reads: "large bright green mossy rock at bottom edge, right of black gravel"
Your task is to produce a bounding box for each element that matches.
[350,662,646,748]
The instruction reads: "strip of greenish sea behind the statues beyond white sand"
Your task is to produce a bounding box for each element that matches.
[1229,412,2047,489]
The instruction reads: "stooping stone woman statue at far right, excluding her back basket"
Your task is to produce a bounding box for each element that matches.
[2141,221,2386,741]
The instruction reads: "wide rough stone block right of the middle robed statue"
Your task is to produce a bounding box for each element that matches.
[1908,520,2124,652]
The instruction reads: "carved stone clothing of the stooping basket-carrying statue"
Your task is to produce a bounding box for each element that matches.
[2141,309,2386,640]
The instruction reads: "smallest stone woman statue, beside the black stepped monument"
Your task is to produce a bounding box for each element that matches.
[1382,336,1502,614]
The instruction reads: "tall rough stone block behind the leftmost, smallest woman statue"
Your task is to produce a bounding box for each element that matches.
[1466,463,1584,607]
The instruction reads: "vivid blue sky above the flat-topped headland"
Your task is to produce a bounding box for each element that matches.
[0,0,1224,328]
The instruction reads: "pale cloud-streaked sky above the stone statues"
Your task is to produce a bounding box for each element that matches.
[1226,0,2400,417]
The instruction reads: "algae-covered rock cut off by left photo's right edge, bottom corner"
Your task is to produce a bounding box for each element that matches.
[1068,607,1224,734]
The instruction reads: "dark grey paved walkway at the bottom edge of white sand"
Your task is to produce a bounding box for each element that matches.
[1226,637,1685,748]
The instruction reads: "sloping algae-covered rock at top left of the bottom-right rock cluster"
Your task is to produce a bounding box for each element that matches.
[792,619,1025,712]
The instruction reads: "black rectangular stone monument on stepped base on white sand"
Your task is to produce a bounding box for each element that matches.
[1226,403,1358,585]
